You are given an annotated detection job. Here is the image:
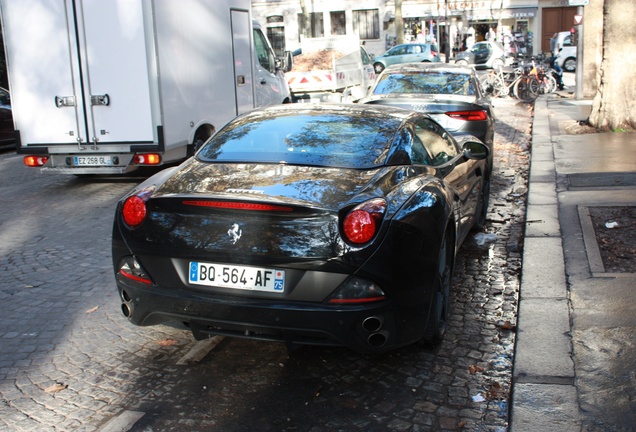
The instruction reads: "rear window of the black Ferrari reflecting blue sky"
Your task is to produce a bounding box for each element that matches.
[197,112,400,168]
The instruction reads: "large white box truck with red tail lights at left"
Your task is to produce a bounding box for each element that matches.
[0,0,290,174]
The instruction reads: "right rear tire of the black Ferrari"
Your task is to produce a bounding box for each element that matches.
[422,229,455,345]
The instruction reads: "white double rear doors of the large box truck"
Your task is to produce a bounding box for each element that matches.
[1,0,154,153]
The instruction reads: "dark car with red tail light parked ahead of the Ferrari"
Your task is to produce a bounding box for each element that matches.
[360,63,495,177]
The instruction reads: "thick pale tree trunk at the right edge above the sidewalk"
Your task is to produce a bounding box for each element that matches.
[588,0,636,131]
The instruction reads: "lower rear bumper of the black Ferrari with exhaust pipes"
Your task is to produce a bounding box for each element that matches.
[116,275,426,353]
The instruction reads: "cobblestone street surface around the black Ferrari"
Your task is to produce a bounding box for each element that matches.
[0,99,532,432]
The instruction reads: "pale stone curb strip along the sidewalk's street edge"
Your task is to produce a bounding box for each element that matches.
[510,96,581,432]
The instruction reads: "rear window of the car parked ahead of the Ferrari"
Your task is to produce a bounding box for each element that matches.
[373,72,475,95]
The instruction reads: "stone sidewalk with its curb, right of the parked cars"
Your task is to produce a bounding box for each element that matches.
[510,94,636,432]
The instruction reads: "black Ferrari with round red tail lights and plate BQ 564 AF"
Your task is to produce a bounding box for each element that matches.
[112,104,488,352]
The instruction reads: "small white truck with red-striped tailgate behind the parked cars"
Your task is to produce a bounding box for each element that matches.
[285,36,375,102]
